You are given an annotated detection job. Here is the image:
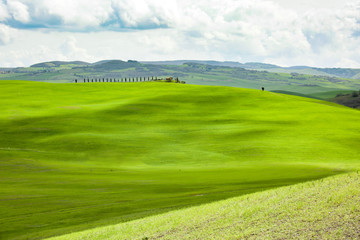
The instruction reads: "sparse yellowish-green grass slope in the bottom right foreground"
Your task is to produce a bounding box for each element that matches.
[51,173,360,240]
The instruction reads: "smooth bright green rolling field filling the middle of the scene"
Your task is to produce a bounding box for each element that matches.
[0,81,360,239]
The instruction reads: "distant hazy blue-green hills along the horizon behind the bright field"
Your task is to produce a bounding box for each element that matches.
[0,60,360,98]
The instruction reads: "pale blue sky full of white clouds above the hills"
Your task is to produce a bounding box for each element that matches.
[0,0,360,68]
